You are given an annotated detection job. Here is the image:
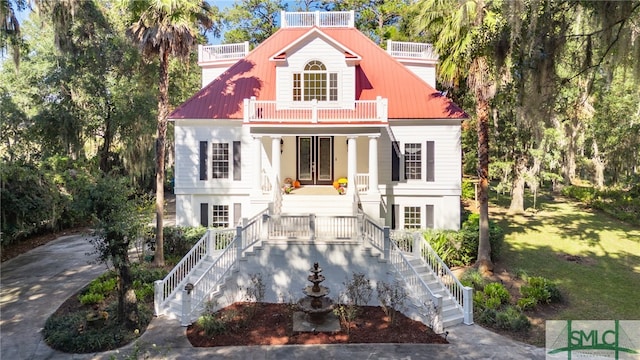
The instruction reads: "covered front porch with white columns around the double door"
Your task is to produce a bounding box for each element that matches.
[252,128,381,199]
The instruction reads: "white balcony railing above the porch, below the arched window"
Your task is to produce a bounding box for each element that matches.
[244,97,388,124]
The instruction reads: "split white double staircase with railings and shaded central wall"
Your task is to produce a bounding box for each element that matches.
[154,215,473,332]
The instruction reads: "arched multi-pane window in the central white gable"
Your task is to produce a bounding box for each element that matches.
[293,60,338,101]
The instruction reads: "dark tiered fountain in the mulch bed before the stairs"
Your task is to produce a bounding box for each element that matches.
[293,262,340,332]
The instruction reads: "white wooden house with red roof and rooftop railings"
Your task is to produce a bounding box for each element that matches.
[170,12,467,229]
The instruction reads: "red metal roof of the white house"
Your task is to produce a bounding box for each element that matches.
[169,28,467,120]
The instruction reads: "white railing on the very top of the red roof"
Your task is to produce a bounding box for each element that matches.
[280,11,355,28]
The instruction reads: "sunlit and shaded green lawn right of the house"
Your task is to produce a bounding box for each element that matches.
[491,193,640,320]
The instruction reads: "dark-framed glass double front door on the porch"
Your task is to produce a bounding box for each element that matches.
[297,136,333,185]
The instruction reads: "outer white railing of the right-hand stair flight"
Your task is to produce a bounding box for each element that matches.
[412,232,473,325]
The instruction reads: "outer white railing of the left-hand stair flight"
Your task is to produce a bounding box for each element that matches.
[154,229,234,316]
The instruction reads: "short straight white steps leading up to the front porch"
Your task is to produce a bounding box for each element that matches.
[281,193,353,216]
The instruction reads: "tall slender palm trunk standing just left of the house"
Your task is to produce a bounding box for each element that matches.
[153,49,169,267]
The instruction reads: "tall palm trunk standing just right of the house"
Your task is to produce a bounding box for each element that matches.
[476,96,493,274]
